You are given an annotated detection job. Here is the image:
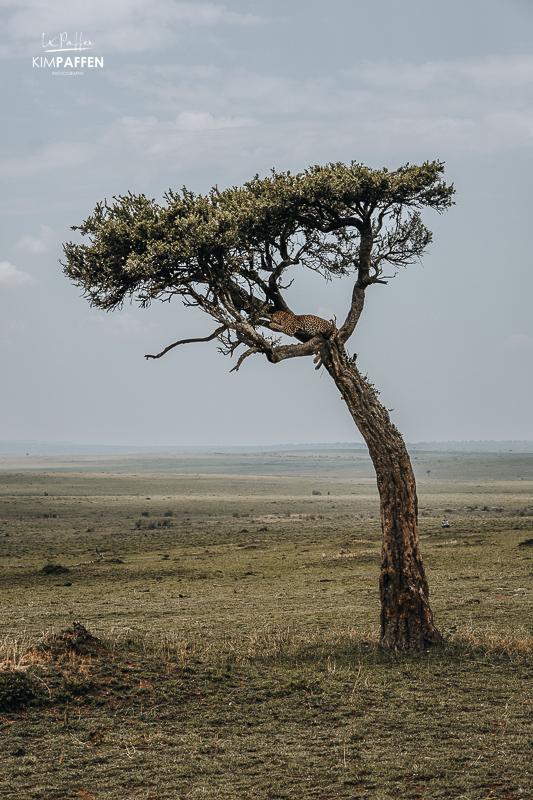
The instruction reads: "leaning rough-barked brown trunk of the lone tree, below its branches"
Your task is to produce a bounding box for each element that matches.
[320,337,442,650]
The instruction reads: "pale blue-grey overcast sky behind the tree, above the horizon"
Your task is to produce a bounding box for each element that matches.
[0,0,533,445]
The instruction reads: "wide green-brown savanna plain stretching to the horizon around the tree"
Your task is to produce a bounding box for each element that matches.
[0,450,533,800]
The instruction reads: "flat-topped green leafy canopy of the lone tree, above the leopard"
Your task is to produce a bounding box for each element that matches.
[64,161,454,325]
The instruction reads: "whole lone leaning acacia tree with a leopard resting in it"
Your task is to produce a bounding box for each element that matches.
[64,161,454,650]
